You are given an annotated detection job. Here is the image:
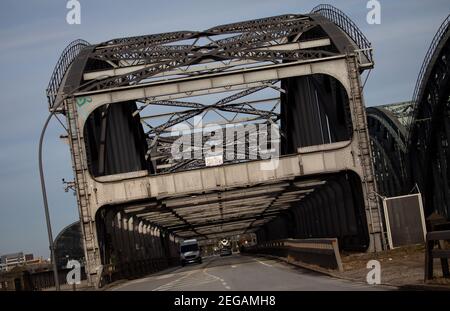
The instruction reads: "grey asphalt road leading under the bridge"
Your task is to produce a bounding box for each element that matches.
[111,254,386,291]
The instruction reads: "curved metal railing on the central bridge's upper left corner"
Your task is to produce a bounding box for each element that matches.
[46,39,90,110]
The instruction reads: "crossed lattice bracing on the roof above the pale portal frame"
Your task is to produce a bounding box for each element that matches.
[83,15,336,91]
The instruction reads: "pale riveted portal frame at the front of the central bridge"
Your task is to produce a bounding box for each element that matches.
[64,54,383,284]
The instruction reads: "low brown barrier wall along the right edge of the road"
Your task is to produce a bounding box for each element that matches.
[242,238,343,271]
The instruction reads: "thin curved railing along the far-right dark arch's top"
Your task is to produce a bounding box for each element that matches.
[408,15,450,133]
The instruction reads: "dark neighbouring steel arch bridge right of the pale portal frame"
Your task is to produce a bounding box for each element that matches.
[367,16,450,225]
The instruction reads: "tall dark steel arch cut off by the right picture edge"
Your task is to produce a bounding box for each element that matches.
[408,15,450,221]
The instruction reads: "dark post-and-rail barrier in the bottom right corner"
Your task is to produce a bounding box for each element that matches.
[425,230,450,281]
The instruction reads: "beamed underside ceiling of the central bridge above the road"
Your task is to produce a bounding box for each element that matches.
[115,177,326,239]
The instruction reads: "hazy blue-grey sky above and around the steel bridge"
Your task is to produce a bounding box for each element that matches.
[0,0,450,257]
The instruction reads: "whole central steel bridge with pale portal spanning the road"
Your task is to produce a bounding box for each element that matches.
[47,5,383,285]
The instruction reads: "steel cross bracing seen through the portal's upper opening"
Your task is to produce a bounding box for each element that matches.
[138,81,284,172]
